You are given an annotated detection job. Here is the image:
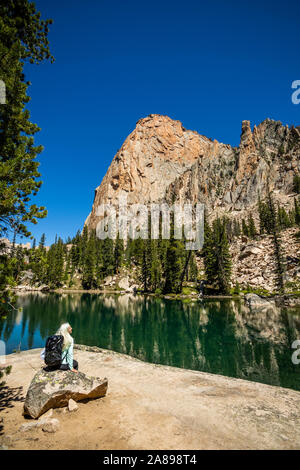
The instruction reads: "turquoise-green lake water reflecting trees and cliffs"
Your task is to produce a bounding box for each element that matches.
[0,293,300,390]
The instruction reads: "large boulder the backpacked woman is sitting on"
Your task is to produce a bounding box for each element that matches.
[24,369,108,418]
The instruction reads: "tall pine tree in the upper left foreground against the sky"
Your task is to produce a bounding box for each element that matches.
[0,0,54,236]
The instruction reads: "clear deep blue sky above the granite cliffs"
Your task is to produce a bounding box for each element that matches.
[18,0,300,244]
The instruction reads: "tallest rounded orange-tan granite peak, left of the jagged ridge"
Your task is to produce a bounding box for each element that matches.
[86,114,214,228]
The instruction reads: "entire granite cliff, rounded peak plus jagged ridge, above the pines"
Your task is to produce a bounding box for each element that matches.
[86,114,300,229]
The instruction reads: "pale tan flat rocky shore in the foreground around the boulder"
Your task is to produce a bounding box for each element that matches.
[0,345,300,450]
